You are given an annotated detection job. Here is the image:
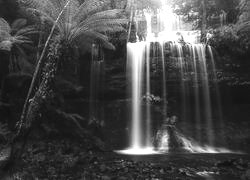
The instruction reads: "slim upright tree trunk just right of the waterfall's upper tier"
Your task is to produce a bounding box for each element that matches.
[201,0,207,42]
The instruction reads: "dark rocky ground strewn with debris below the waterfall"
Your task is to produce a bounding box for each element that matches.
[0,138,250,180]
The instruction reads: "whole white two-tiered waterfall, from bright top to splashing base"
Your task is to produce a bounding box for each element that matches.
[118,0,232,154]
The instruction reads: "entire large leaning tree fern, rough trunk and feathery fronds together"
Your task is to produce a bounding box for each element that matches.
[13,0,127,142]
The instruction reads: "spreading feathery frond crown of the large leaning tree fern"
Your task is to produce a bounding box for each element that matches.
[20,0,126,50]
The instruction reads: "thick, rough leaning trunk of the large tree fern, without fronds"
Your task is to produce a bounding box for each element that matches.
[7,38,63,168]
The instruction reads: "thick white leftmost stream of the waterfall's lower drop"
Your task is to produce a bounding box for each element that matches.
[122,42,157,154]
